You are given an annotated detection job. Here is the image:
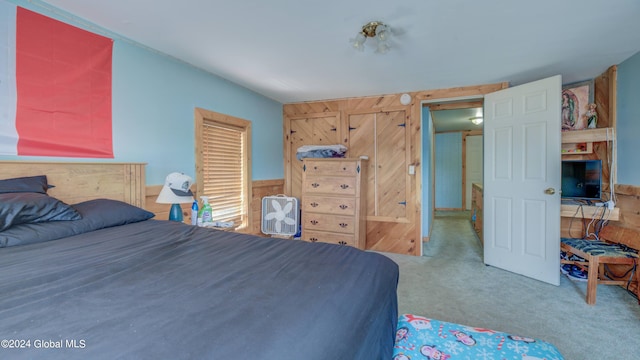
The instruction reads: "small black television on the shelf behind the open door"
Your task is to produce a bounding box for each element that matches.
[562,160,602,201]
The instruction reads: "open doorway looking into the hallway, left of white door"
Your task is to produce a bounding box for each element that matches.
[423,99,483,259]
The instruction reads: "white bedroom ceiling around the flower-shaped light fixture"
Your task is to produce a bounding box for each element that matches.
[45,0,640,103]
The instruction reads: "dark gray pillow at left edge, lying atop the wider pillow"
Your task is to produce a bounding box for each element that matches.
[0,192,81,231]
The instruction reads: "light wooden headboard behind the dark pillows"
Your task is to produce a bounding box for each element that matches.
[0,161,145,208]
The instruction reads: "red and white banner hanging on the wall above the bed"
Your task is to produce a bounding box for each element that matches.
[0,0,113,158]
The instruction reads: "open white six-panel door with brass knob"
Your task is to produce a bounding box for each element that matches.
[484,75,562,285]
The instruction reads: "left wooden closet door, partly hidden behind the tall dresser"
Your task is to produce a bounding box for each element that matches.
[288,113,341,199]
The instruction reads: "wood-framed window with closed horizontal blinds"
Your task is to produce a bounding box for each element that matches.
[195,108,251,229]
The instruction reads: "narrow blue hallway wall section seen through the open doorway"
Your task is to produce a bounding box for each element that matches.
[434,132,462,209]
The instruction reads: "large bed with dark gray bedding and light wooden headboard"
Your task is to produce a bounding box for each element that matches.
[0,162,398,360]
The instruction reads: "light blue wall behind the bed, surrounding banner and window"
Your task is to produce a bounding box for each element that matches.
[0,0,284,185]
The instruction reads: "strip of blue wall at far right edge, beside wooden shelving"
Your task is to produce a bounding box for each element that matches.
[616,52,640,186]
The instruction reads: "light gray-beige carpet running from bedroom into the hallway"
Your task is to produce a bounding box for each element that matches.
[385,211,640,360]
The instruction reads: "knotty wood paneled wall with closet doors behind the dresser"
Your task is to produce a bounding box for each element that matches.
[283,93,421,255]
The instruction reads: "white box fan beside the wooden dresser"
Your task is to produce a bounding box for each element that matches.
[261,195,300,237]
